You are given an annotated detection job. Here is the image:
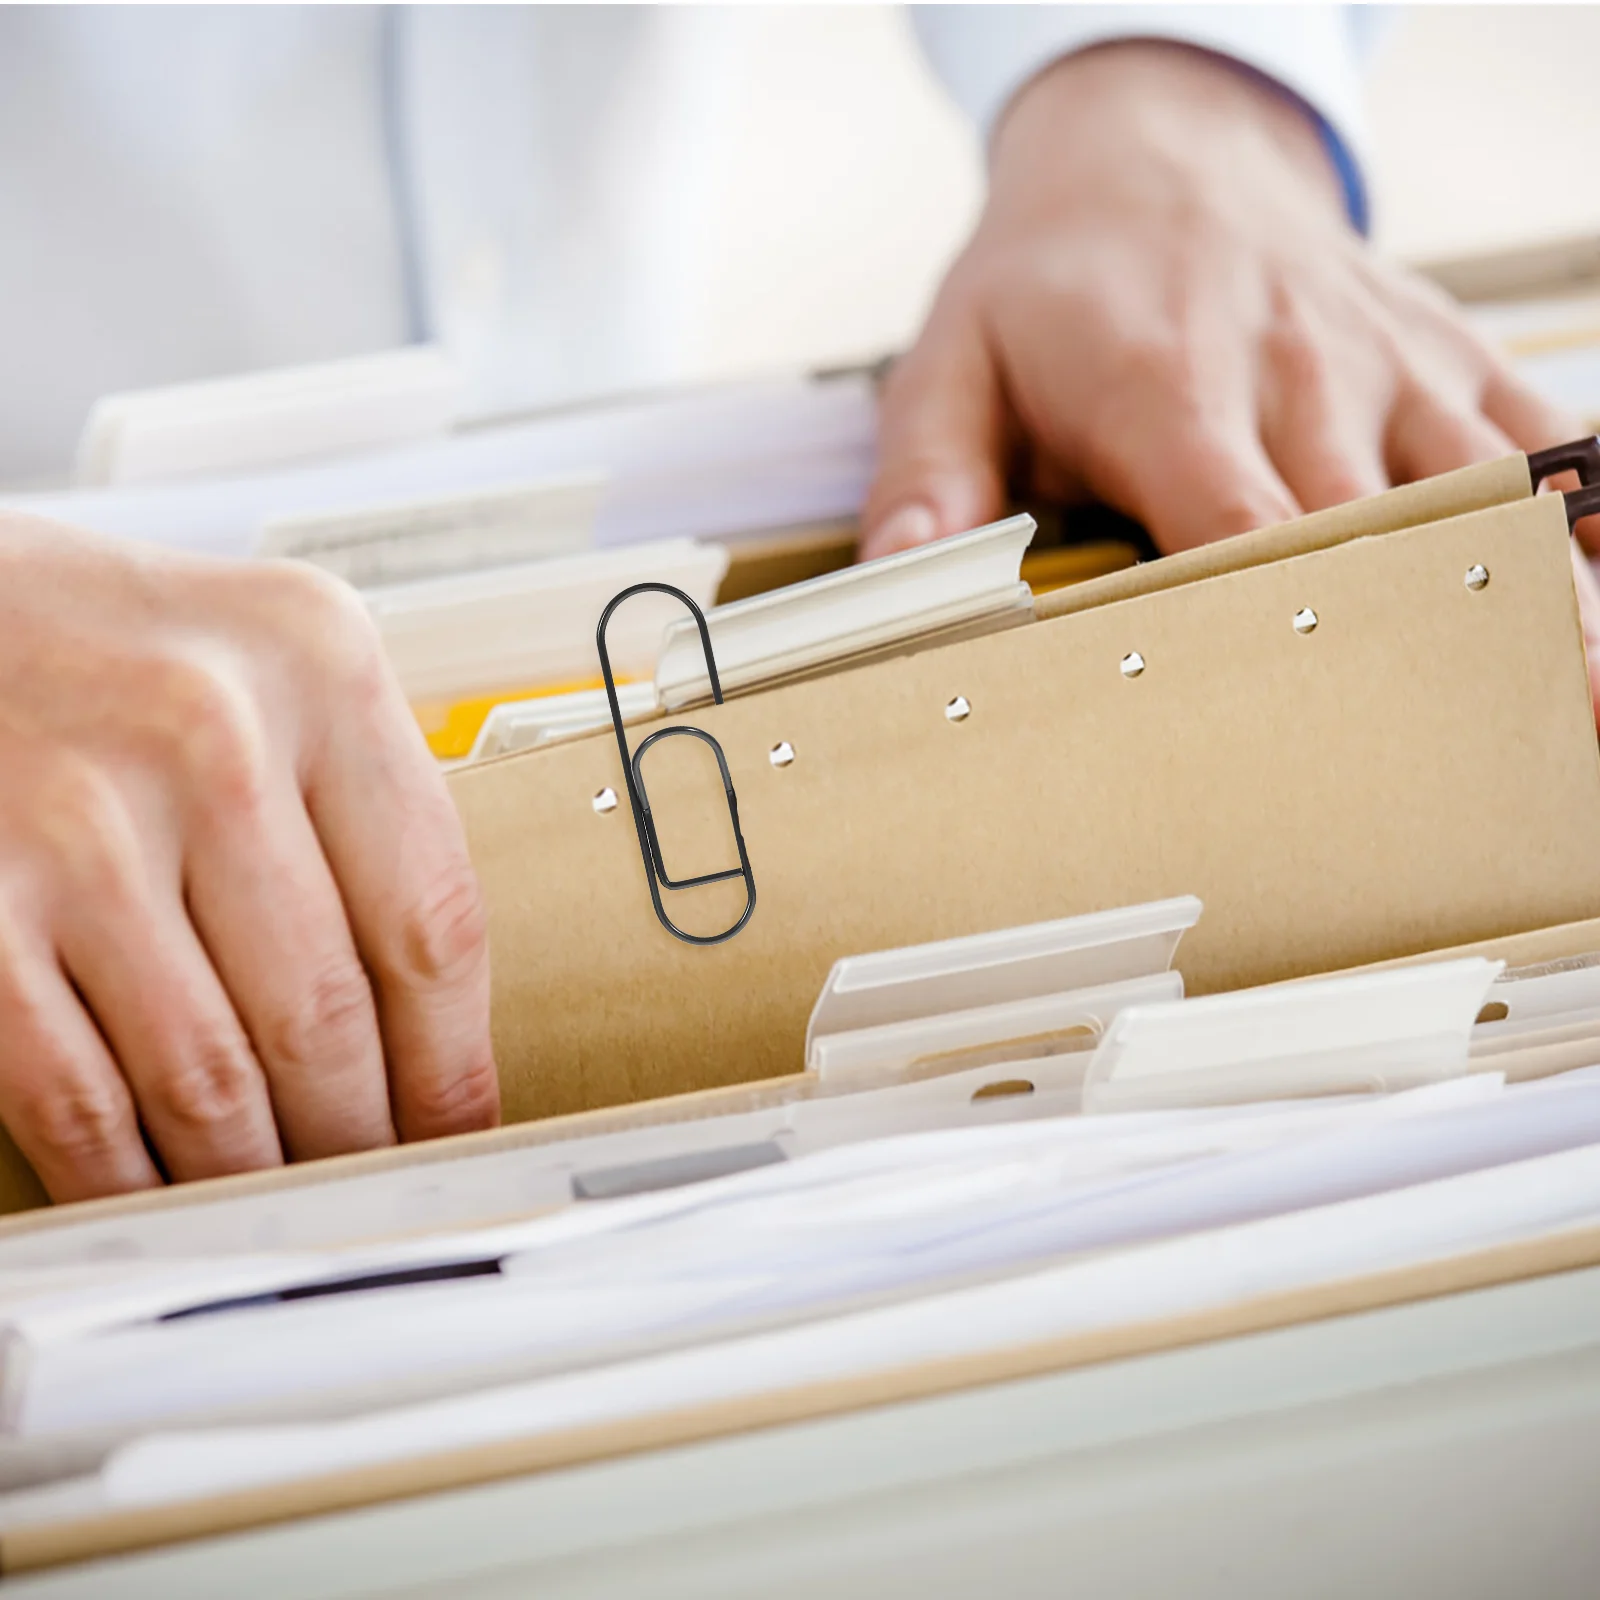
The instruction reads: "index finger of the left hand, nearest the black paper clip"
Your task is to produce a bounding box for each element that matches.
[296,592,499,1139]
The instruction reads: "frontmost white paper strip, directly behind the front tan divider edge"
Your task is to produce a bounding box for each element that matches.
[62,1146,1600,1525]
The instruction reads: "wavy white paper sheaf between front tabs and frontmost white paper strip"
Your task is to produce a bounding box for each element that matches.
[5,1078,1600,1434]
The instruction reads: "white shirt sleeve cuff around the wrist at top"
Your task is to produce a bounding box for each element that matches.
[912,5,1371,160]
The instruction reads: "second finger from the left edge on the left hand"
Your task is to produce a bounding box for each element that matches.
[46,773,283,1181]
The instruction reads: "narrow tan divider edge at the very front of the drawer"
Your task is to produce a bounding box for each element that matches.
[12,1227,1600,1573]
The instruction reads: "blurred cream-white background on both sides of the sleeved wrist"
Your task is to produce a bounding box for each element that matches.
[682,5,1600,376]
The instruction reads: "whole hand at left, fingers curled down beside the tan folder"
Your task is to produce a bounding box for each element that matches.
[0,515,499,1200]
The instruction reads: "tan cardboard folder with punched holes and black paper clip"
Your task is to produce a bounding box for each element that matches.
[451,456,1600,1120]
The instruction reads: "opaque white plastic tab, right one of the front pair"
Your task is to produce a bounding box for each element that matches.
[1083,958,1504,1112]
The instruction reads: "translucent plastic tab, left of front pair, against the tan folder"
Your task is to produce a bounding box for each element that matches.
[806,894,1202,1078]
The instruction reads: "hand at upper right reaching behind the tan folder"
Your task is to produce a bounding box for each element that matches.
[861,42,1574,557]
